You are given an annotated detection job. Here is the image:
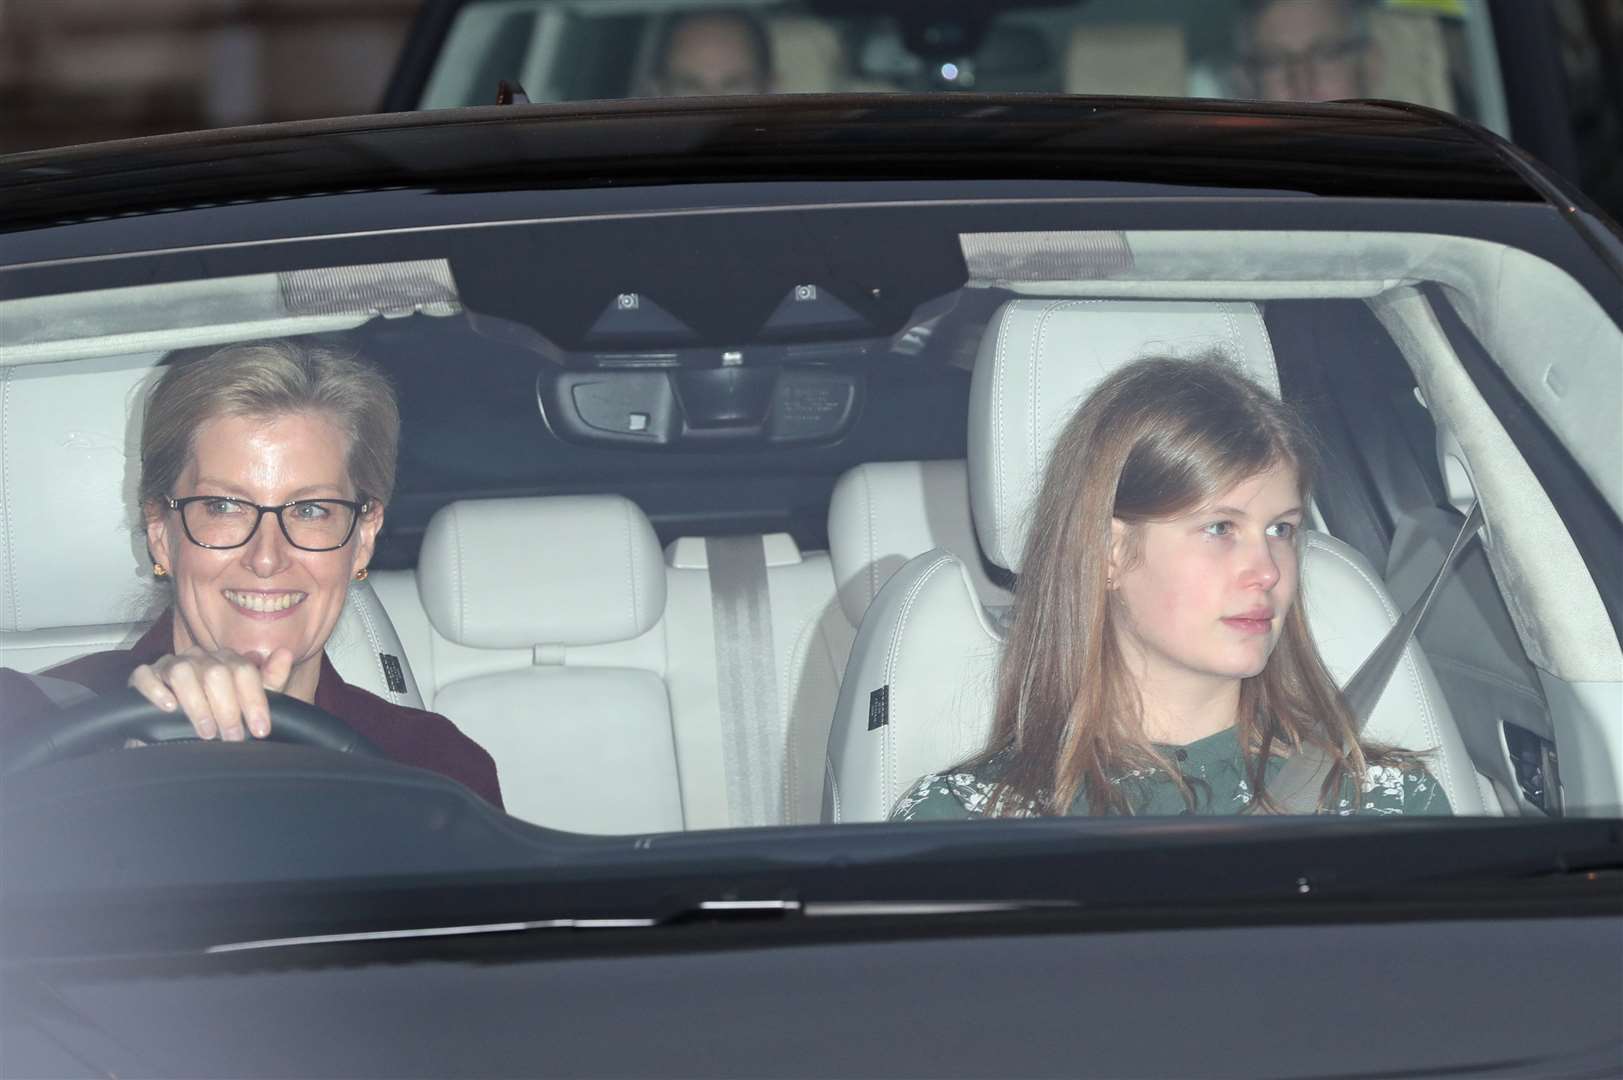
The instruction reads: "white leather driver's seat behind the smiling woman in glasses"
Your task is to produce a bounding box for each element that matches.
[0,352,422,708]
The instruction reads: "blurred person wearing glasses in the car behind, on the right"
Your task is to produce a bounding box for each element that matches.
[1235,0,1381,101]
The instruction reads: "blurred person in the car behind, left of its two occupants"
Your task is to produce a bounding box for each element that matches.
[652,10,773,97]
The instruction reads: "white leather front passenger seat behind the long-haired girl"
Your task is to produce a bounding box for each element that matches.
[824,299,1490,822]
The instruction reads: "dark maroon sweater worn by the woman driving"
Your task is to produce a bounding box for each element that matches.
[0,612,502,807]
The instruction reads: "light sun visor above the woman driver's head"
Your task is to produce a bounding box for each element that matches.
[0,260,463,365]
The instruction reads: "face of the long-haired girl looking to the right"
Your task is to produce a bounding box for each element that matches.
[1112,466,1302,685]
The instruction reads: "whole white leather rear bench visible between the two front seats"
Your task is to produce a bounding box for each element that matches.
[375,495,855,833]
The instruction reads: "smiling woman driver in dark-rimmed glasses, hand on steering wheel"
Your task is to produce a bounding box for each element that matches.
[0,339,502,806]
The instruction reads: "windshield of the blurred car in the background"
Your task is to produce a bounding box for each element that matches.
[419,0,1508,135]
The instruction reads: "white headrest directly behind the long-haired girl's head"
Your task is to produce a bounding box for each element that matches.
[969,300,1279,573]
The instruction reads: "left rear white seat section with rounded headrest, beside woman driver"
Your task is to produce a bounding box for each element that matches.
[414,495,682,832]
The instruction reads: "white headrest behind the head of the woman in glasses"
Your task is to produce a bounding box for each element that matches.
[0,356,162,632]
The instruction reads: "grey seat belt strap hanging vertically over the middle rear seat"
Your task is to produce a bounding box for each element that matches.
[704,536,784,825]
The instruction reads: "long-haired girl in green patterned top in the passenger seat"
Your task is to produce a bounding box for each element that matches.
[891,359,1449,820]
